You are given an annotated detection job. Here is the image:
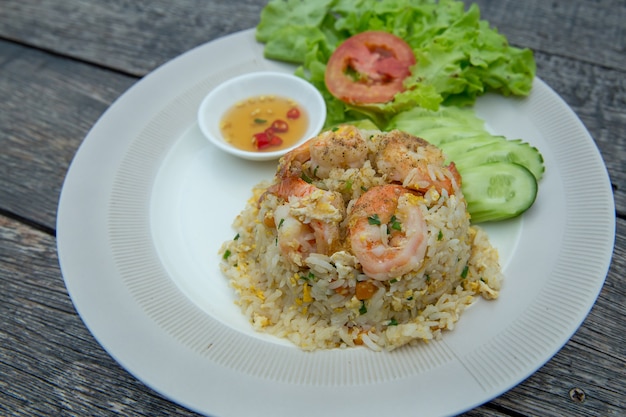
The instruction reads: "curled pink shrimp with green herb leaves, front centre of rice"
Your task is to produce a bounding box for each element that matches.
[348,184,428,281]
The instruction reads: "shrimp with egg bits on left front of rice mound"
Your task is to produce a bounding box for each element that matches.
[267,177,345,266]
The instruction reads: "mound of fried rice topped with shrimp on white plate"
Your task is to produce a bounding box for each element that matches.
[220,126,502,350]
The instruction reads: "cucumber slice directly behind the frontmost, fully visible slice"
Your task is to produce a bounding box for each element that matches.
[454,139,545,181]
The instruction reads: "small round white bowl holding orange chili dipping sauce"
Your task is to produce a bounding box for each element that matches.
[197,71,326,161]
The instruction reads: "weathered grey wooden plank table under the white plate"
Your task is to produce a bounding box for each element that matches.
[0,0,626,416]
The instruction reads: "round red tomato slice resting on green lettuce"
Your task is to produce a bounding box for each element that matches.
[325,31,416,104]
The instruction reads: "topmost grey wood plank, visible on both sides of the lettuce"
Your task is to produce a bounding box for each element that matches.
[0,0,626,75]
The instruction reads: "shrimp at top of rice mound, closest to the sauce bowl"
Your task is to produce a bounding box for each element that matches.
[277,125,369,178]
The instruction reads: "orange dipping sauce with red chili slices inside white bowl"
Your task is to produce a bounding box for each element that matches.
[220,95,309,152]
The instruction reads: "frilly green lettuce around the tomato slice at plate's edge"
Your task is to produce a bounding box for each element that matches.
[256,0,536,129]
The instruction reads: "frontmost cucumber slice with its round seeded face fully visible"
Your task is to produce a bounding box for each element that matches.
[461,162,537,223]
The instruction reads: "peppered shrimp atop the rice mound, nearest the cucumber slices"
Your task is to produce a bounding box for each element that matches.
[375,130,461,195]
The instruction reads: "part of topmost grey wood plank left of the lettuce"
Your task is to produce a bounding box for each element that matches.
[0,0,266,76]
